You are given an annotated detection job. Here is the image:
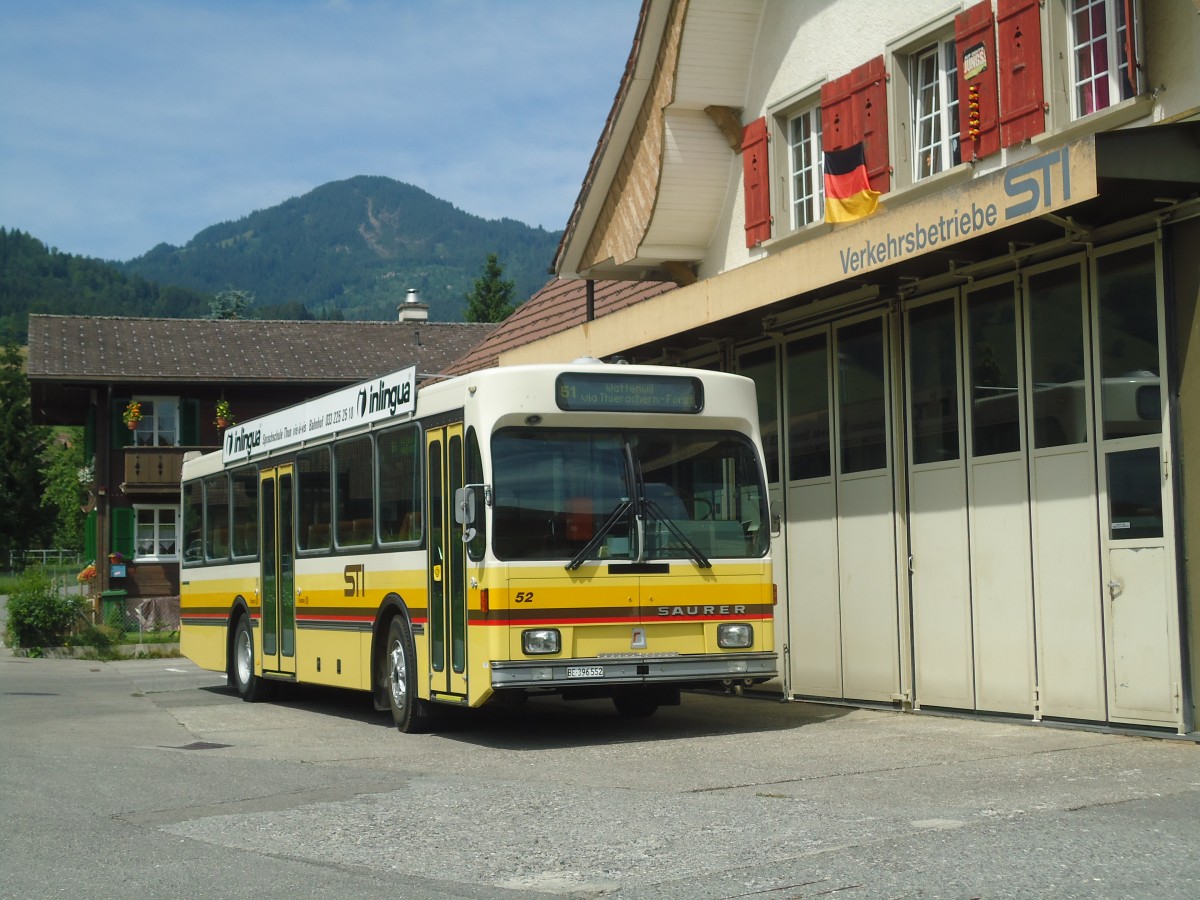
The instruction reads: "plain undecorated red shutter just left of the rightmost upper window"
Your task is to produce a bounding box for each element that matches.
[996,0,1046,146]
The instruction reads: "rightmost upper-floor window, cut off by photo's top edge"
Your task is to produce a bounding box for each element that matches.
[1067,0,1138,119]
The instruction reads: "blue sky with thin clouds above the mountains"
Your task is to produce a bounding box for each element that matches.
[0,0,641,259]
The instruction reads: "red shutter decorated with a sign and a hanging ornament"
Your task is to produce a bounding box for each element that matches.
[954,0,1000,162]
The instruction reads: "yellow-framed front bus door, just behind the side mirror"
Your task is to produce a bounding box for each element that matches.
[425,425,467,698]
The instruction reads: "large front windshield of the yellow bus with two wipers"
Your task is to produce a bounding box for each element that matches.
[492,428,770,568]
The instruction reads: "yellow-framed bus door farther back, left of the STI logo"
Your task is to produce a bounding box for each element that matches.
[258,466,296,674]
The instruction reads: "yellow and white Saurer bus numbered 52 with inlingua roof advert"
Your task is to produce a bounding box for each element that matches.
[180,360,778,732]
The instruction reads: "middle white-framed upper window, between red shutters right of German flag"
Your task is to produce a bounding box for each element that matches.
[908,37,962,181]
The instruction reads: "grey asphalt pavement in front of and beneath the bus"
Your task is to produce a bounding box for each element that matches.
[0,650,1200,900]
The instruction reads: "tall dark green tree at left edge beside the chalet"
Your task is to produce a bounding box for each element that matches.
[0,340,48,565]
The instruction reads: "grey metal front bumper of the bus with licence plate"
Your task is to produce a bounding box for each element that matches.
[491,653,779,690]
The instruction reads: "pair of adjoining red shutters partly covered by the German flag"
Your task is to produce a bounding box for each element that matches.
[821,56,892,193]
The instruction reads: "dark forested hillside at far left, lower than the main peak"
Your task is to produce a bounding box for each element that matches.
[0,228,210,343]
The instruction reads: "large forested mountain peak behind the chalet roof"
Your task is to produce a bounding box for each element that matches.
[118,175,560,322]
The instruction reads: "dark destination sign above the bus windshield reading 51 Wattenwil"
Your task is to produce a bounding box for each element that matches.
[554,372,704,414]
